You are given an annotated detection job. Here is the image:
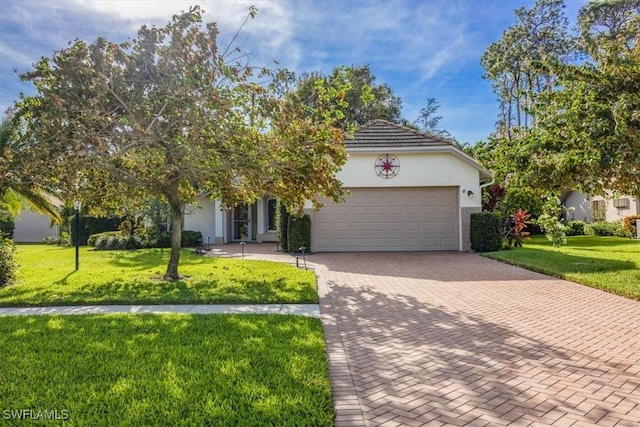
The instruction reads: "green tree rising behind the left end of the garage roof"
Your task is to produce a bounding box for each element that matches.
[292,65,402,127]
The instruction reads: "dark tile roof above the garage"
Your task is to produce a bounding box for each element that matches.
[345,120,455,147]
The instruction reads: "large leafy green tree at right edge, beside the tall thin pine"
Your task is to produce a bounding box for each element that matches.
[527,0,640,195]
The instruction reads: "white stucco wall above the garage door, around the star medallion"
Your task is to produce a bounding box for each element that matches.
[337,152,482,208]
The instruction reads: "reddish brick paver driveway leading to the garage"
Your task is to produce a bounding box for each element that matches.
[225,246,640,427]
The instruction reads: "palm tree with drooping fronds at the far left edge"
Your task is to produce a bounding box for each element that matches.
[0,116,63,224]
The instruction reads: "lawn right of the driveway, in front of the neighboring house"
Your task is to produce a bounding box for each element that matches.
[484,236,640,300]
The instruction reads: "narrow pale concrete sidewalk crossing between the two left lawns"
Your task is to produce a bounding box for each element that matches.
[0,304,320,317]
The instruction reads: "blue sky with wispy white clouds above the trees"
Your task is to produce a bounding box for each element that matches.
[0,0,586,143]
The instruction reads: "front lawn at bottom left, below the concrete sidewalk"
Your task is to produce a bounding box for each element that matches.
[0,315,333,426]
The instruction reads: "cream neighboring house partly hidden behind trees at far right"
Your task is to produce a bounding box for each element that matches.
[561,191,640,222]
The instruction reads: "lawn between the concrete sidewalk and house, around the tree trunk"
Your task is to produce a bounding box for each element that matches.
[0,245,318,306]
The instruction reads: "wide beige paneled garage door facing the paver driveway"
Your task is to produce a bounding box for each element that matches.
[312,187,459,252]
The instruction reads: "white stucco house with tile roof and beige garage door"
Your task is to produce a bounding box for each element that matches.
[185,120,491,252]
